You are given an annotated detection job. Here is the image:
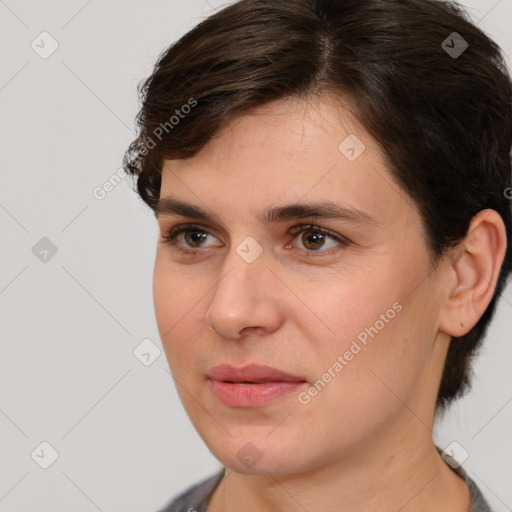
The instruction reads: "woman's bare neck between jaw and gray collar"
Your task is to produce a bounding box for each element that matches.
[207,419,469,512]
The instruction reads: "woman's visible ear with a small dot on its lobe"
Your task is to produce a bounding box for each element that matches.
[439,209,507,337]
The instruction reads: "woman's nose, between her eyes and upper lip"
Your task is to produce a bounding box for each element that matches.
[206,247,282,339]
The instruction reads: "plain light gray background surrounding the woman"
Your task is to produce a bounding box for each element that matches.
[0,0,512,512]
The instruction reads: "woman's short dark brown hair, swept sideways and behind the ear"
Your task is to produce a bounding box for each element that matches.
[123,0,512,408]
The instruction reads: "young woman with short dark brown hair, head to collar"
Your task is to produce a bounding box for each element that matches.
[125,0,512,512]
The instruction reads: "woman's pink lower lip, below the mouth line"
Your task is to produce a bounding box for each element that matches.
[209,379,306,407]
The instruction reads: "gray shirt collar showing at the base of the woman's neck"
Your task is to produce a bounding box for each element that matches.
[158,467,492,512]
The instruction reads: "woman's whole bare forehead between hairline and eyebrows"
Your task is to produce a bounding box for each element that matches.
[161,97,416,227]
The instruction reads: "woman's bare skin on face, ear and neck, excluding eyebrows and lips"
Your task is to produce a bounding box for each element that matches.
[153,96,506,512]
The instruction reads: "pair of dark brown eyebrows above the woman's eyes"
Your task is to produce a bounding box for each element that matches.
[154,197,381,226]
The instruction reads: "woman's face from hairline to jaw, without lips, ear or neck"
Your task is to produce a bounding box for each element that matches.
[153,95,448,475]
